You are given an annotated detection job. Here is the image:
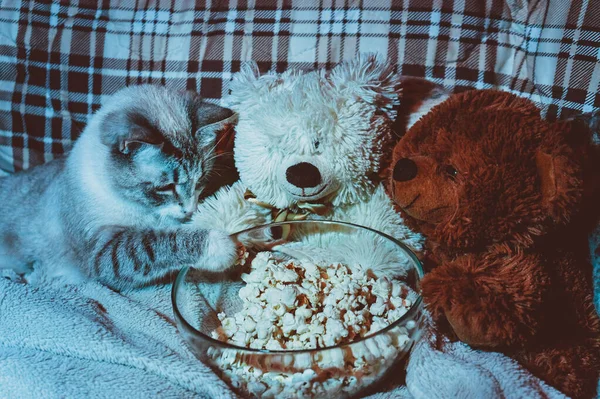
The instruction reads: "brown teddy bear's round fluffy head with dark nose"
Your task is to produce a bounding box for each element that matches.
[388,90,581,251]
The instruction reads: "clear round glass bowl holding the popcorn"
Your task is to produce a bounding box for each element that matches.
[172,220,424,399]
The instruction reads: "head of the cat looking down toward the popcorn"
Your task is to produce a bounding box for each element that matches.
[94,85,235,221]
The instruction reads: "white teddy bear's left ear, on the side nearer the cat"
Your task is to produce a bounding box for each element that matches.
[226,61,283,110]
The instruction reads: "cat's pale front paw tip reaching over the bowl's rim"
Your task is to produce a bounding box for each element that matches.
[196,230,239,272]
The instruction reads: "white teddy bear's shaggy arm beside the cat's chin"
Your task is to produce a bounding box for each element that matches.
[192,181,271,233]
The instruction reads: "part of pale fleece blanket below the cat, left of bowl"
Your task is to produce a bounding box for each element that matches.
[0,279,235,399]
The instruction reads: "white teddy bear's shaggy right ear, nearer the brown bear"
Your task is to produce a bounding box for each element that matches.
[328,54,400,109]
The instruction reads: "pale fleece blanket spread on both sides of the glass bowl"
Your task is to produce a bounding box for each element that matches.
[0,272,576,399]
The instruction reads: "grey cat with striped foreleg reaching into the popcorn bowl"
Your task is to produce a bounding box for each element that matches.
[0,85,236,288]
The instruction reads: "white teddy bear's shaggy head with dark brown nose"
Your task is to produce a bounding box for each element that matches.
[227,55,399,208]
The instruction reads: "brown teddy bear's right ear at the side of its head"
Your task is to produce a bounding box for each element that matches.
[535,137,582,223]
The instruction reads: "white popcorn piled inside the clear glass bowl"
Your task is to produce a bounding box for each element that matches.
[208,251,416,398]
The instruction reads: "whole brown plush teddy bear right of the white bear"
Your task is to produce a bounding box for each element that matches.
[388,90,600,397]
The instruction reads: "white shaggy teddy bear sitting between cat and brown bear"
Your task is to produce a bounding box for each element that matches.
[195,55,423,276]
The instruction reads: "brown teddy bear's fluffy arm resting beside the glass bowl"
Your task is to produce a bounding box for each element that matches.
[422,251,549,348]
